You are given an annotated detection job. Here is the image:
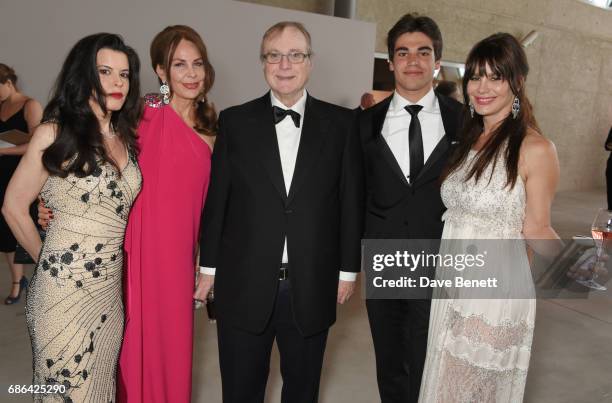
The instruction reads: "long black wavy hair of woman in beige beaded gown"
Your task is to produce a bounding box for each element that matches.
[42,33,142,178]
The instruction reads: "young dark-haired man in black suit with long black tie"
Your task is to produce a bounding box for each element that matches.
[358,14,462,403]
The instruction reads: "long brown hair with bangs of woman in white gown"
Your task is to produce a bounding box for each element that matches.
[442,33,541,189]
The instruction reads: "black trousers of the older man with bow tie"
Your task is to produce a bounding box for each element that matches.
[217,280,328,403]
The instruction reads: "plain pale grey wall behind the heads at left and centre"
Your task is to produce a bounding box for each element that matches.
[0,0,376,110]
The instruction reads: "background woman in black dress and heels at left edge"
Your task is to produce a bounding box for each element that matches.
[0,63,42,305]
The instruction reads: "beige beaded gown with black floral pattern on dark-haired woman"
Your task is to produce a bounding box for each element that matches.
[26,155,141,402]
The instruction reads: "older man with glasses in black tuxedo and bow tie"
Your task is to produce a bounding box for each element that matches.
[195,22,364,403]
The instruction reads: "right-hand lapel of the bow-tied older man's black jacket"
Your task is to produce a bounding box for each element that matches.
[287,95,330,205]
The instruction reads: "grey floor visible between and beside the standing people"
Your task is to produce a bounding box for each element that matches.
[0,191,612,403]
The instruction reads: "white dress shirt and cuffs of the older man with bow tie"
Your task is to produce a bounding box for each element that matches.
[200,90,357,281]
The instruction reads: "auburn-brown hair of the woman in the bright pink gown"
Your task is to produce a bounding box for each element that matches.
[150,25,217,136]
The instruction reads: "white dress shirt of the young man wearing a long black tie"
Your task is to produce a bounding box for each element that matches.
[382,88,445,184]
